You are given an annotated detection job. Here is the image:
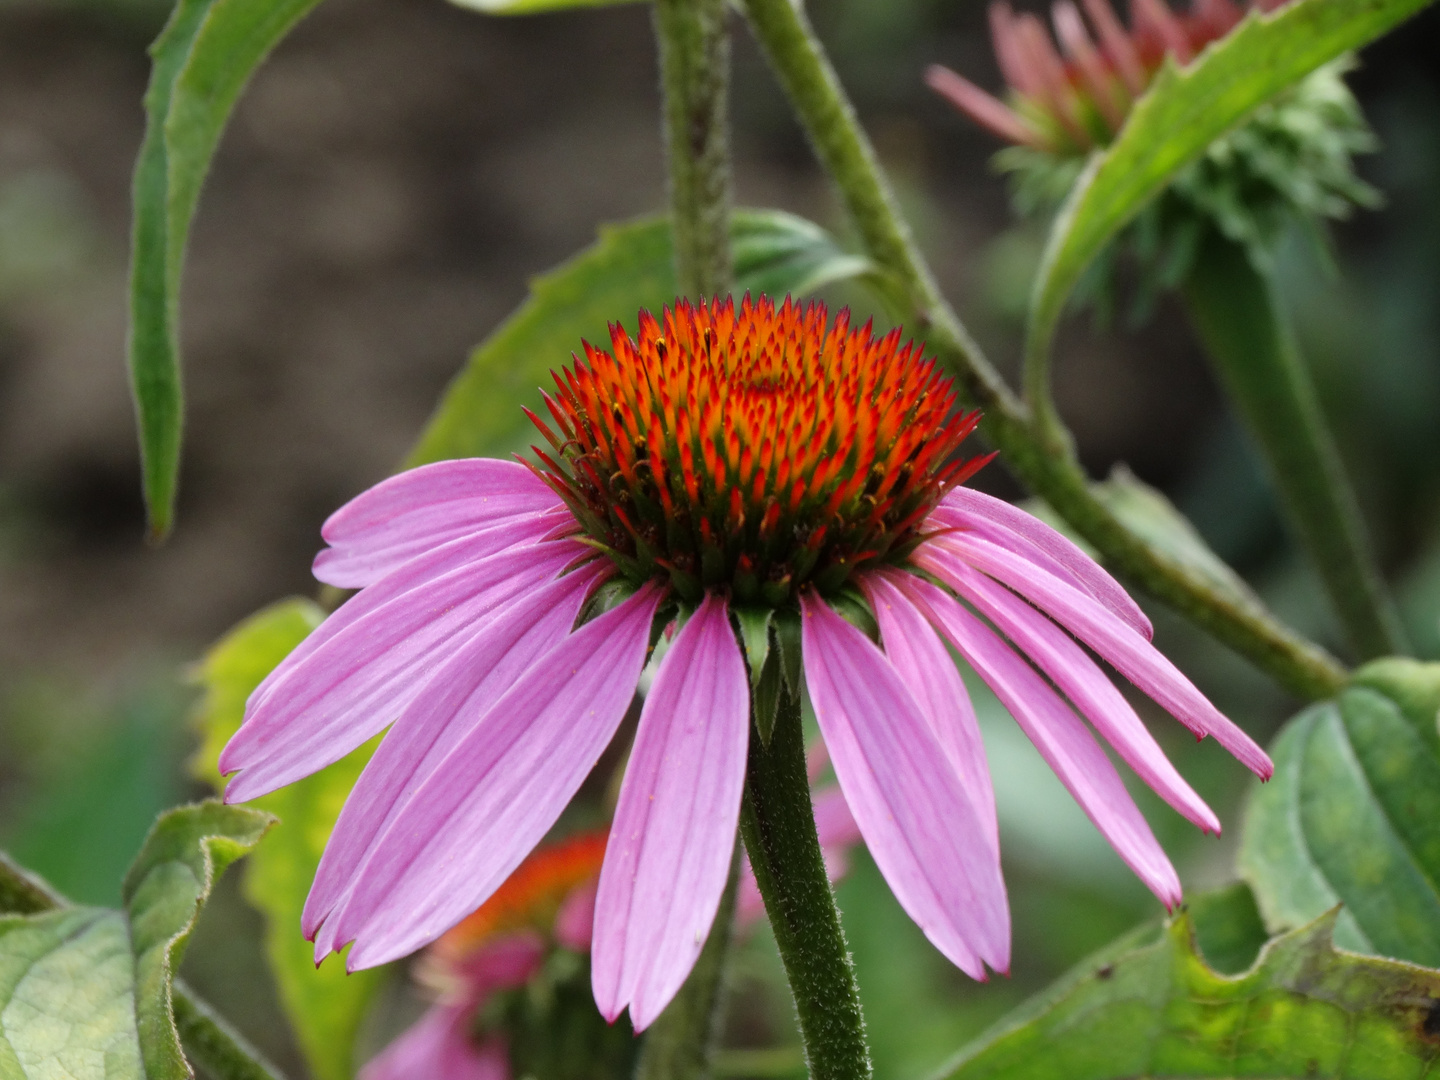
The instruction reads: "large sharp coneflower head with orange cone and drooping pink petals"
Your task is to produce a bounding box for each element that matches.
[220,297,1270,1030]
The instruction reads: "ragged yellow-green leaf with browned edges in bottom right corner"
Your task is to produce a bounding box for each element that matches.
[942,912,1440,1080]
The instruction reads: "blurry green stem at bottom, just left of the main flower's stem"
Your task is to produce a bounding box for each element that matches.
[635,841,740,1080]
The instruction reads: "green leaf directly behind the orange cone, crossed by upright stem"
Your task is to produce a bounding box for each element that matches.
[406,210,874,468]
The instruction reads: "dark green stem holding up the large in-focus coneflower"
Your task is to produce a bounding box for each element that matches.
[740,691,871,1080]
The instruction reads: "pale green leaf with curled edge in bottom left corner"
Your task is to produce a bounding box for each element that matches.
[0,802,272,1080]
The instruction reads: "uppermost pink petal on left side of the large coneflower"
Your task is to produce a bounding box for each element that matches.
[315,458,564,589]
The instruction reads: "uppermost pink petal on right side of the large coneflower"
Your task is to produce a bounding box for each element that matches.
[929,487,1155,641]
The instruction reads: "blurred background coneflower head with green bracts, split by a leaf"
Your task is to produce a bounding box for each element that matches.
[926,0,1378,296]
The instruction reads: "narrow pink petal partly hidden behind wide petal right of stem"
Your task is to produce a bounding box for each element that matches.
[861,572,999,858]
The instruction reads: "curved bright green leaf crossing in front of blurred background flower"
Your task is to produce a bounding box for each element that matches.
[1025,0,1428,368]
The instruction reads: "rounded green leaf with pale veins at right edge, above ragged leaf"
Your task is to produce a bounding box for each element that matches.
[1240,660,1440,966]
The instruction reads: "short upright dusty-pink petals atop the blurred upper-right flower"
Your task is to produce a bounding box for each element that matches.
[926,0,1284,154]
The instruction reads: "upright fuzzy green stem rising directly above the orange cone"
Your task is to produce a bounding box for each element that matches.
[655,0,732,301]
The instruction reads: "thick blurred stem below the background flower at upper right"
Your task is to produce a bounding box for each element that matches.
[1185,232,1405,660]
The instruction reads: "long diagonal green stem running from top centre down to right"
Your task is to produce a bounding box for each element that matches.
[743,0,1348,698]
